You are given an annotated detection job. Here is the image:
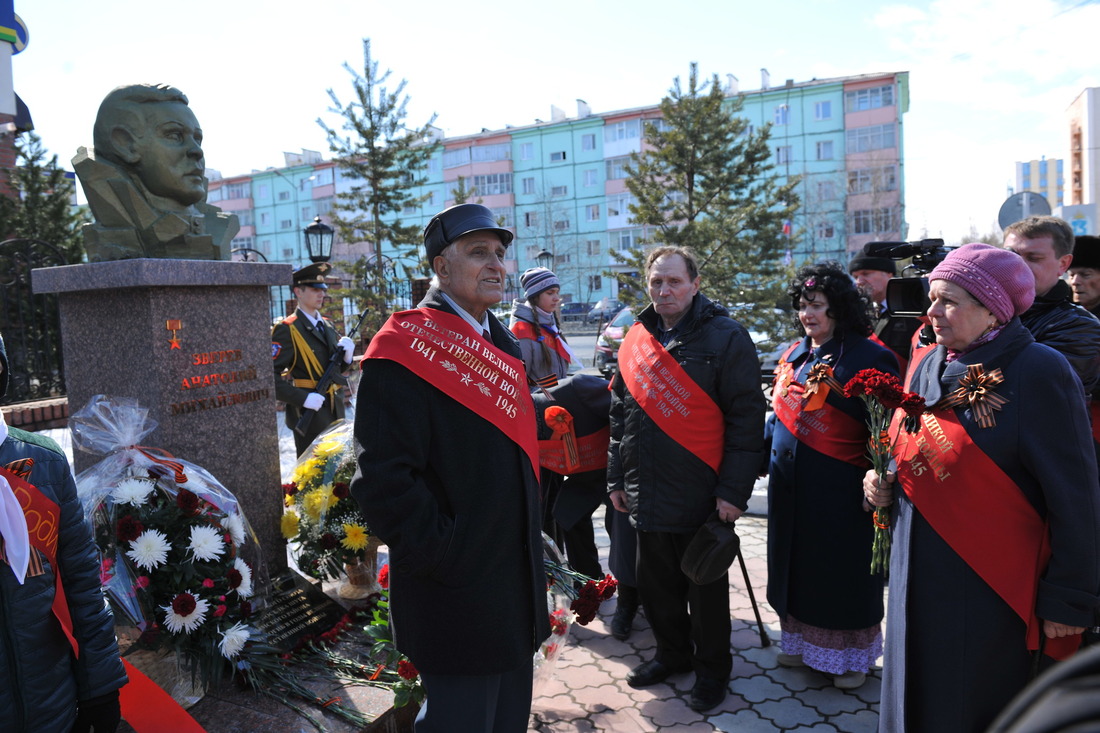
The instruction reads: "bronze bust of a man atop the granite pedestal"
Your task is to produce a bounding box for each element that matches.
[73,84,241,262]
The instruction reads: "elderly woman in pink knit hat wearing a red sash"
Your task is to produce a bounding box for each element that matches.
[864,244,1100,733]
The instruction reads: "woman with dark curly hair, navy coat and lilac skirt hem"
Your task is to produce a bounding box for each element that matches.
[768,262,898,689]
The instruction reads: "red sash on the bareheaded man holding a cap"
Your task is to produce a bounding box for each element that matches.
[618,326,726,473]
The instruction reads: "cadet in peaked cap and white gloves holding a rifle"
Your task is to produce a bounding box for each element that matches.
[272,262,355,456]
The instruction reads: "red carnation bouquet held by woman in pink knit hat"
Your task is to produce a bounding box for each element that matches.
[844,369,924,576]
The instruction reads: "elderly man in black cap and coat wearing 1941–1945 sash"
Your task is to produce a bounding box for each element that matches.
[351,204,550,733]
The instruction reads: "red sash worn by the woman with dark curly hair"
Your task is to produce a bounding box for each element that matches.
[771,343,871,468]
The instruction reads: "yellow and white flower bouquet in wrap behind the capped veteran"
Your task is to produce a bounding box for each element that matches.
[282,419,378,581]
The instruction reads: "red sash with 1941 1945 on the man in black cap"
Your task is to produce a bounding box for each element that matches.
[364,308,539,475]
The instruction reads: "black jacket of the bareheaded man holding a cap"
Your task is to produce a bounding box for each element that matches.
[607,293,765,533]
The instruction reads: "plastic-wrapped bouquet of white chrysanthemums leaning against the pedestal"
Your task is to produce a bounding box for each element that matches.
[69,395,264,698]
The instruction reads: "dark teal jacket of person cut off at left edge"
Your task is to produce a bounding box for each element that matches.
[0,428,127,733]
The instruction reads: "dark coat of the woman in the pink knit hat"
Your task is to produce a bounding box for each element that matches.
[879,319,1100,733]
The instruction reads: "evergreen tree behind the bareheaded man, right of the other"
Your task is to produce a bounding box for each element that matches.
[611,64,799,339]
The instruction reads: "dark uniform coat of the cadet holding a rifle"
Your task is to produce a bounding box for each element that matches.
[272,309,350,446]
